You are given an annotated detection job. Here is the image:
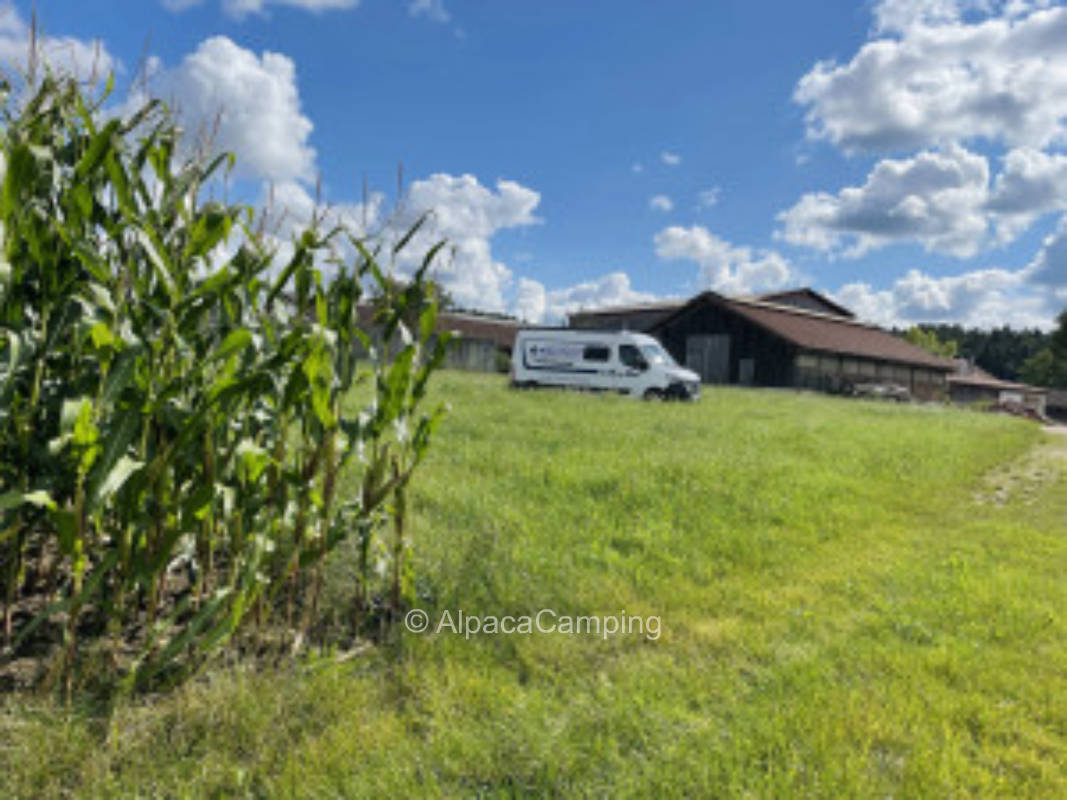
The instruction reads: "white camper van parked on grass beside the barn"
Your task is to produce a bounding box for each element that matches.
[511,329,700,400]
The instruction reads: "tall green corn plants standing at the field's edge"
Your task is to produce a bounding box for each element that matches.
[0,76,446,691]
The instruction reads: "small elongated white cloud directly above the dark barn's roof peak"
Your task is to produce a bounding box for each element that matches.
[654,225,795,294]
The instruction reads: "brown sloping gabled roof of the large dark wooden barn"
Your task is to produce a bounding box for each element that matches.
[655,291,955,372]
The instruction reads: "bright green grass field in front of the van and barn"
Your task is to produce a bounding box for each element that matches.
[0,373,1067,798]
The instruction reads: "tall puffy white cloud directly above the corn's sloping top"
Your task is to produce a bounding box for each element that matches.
[152,36,316,181]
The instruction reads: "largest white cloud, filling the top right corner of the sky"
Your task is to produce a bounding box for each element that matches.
[794,0,1067,151]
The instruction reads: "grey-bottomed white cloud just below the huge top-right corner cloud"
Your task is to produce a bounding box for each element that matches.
[778,145,989,257]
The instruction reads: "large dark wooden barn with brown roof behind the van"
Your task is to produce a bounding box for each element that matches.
[570,289,955,399]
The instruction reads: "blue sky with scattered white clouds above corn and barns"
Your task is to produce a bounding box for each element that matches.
[6,0,1067,329]
